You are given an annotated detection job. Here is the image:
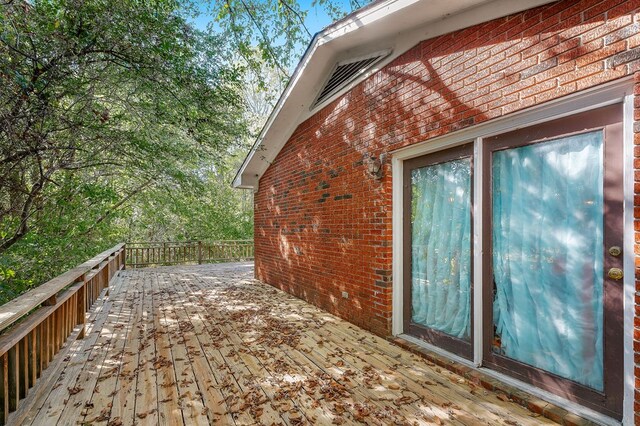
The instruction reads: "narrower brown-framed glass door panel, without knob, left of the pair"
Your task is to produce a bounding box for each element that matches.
[404,145,472,357]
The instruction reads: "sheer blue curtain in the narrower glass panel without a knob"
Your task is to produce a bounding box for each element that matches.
[411,158,471,340]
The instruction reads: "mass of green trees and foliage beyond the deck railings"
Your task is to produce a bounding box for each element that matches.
[0,0,360,304]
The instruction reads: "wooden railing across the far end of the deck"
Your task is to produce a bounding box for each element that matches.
[126,240,253,268]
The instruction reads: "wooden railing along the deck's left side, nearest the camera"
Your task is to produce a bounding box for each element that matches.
[0,244,125,425]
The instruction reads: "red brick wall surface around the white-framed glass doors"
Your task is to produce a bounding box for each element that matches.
[255,0,640,416]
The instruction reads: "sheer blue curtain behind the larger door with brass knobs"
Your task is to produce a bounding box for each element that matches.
[492,132,603,390]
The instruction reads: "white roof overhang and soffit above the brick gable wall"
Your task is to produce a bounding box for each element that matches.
[233,0,553,189]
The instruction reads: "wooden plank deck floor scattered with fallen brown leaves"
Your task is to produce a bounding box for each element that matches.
[25,263,549,426]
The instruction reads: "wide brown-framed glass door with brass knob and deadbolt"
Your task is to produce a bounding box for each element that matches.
[484,106,622,416]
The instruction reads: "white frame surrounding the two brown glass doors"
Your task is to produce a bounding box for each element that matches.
[391,78,635,424]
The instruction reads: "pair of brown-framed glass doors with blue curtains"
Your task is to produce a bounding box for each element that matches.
[402,104,623,418]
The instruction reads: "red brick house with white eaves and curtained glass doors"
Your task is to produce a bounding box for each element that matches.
[234,0,640,424]
